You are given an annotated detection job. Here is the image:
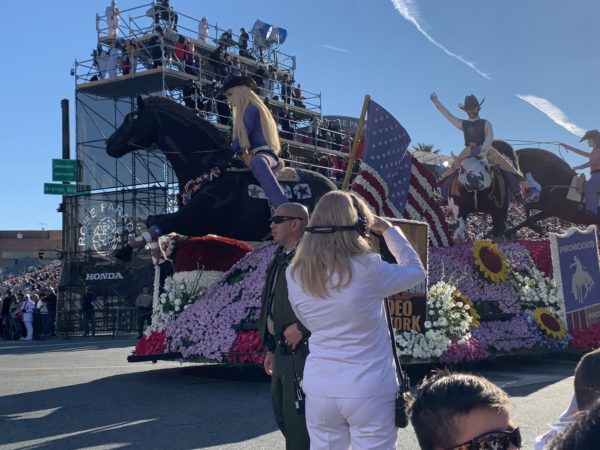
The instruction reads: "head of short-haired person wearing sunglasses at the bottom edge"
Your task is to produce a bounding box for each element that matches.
[410,371,521,450]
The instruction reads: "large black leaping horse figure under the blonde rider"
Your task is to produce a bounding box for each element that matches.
[106,97,336,250]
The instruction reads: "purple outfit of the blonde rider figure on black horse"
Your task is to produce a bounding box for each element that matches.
[231,105,288,208]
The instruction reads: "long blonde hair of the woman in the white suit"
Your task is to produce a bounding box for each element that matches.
[291,191,373,298]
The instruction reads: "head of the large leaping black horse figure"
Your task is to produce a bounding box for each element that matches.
[106,96,156,158]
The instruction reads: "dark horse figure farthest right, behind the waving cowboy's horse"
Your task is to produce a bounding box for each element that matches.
[509,148,598,233]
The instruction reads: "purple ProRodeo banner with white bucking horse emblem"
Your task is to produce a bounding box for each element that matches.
[550,225,600,331]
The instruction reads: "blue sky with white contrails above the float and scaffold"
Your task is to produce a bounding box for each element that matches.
[0,0,600,230]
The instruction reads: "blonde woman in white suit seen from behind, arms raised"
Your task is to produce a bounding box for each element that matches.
[286,191,425,450]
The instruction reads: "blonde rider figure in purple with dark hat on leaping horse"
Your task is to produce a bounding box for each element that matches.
[223,77,288,208]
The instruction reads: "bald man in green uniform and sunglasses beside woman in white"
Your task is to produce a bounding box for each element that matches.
[259,203,310,450]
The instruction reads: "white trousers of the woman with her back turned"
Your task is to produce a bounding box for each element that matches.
[306,394,398,450]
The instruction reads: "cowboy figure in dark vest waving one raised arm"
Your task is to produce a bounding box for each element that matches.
[431,92,528,199]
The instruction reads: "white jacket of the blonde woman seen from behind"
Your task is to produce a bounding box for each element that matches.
[286,227,425,398]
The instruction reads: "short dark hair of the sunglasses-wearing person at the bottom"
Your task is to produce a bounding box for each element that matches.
[410,371,509,450]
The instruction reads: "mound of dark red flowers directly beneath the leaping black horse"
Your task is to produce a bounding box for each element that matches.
[173,236,252,272]
